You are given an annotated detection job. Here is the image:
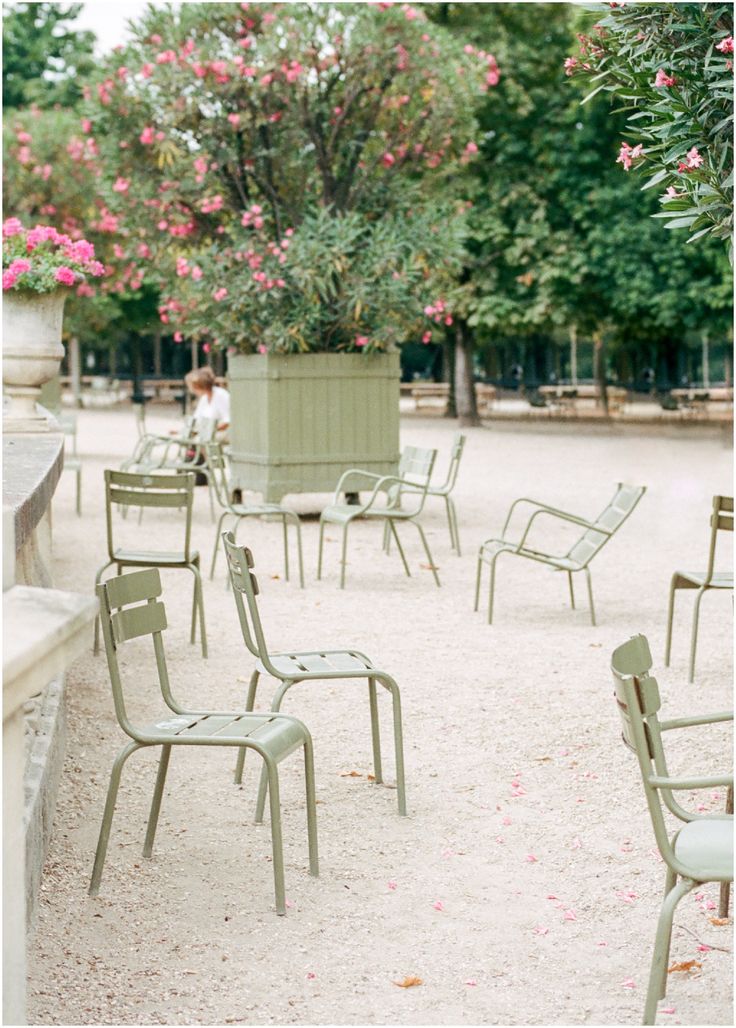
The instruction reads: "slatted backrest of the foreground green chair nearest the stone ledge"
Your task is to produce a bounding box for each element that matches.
[97,567,177,739]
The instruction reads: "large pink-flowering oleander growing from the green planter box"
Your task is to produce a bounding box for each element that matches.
[84,3,499,352]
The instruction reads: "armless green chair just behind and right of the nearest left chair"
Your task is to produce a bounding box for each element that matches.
[222,531,406,820]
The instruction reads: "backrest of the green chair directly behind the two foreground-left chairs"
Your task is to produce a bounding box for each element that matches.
[105,468,195,561]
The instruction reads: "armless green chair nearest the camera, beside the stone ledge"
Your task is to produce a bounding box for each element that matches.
[89,568,319,914]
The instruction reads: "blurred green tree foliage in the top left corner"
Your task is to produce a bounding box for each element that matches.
[2,3,95,110]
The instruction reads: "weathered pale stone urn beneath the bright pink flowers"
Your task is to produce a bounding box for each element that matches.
[2,289,68,432]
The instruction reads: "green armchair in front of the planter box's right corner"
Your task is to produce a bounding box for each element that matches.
[317,446,440,589]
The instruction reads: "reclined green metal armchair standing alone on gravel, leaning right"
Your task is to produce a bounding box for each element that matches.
[474,482,647,625]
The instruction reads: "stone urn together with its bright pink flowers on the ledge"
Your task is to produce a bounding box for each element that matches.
[2,218,105,432]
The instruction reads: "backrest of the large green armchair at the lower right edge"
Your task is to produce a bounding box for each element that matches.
[611,635,675,864]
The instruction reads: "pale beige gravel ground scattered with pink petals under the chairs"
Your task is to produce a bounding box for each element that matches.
[29,408,733,1025]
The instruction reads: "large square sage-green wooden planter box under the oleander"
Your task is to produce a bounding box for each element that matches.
[227,354,400,503]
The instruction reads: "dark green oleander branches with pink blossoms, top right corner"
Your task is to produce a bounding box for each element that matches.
[564,2,734,242]
